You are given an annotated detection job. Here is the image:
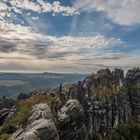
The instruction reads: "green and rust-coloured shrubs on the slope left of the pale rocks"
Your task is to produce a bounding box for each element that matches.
[0,95,54,134]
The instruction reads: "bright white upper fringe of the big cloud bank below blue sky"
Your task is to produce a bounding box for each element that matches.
[0,22,123,50]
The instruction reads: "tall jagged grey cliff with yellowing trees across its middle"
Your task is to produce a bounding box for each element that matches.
[83,69,131,135]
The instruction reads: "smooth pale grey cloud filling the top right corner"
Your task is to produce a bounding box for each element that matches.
[74,0,140,26]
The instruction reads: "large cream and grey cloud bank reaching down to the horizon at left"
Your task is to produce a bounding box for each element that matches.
[0,21,129,72]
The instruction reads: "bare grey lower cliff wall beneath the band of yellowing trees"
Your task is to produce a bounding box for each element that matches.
[92,93,131,134]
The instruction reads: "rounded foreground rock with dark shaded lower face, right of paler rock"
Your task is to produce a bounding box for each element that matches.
[58,99,85,140]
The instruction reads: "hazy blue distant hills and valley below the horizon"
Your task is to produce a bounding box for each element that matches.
[0,72,86,97]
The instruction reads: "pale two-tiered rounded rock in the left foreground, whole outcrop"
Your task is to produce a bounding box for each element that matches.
[12,103,59,140]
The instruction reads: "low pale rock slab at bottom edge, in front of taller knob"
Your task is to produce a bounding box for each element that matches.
[13,119,59,140]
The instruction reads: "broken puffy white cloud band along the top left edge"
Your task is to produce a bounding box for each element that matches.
[0,0,79,20]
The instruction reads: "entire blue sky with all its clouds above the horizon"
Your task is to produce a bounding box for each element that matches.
[0,0,140,73]
